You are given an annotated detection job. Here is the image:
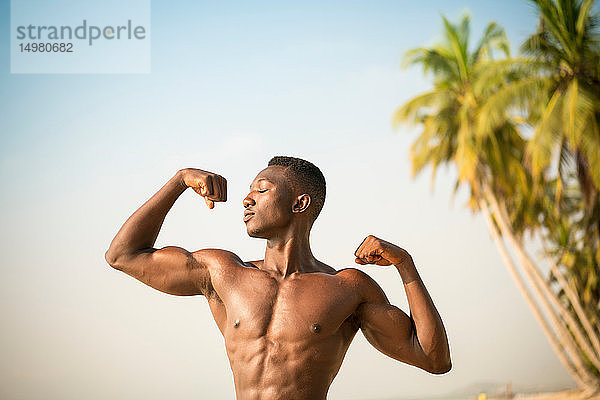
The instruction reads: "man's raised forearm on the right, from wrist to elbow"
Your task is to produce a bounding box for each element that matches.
[396,257,451,372]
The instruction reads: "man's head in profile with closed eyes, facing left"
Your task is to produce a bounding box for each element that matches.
[244,156,325,238]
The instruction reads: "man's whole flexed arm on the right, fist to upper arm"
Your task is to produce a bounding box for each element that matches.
[354,235,452,374]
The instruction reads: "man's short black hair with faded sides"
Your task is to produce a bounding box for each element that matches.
[268,156,325,220]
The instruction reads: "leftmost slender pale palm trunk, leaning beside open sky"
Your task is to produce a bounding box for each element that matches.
[479,199,587,387]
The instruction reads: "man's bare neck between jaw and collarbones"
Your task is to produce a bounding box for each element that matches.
[262,228,318,278]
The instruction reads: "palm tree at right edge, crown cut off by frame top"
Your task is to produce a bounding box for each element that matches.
[479,0,600,388]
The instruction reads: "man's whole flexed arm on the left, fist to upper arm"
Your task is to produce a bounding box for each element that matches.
[105,168,227,296]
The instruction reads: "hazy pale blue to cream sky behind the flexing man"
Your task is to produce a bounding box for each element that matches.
[0,0,572,400]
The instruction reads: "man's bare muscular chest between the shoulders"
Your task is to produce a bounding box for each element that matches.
[212,269,359,342]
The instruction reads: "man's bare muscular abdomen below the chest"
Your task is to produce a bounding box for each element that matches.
[225,332,352,400]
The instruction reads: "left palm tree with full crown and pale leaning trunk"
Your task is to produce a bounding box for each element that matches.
[394,10,600,394]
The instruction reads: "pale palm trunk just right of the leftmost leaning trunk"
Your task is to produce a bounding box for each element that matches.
[486,188,600,389]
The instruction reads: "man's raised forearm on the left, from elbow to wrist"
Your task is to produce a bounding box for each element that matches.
[106,171,187,263]
